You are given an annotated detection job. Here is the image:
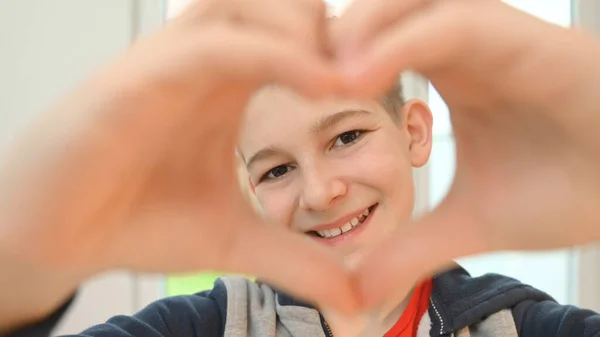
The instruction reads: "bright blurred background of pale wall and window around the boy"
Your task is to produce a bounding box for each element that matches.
[0,0,600,334]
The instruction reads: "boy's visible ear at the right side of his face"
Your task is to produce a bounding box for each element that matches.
[402,99,433,167]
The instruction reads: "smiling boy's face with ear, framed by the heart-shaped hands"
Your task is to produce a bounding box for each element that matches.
[239,87,431,256]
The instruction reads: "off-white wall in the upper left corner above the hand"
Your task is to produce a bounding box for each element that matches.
[0,0,131,155]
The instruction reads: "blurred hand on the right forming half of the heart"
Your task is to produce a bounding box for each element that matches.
[335,0,600,307]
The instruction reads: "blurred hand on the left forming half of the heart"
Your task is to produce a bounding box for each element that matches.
[0,0,356,328]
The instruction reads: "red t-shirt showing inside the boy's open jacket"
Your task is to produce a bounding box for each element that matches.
[383,279,433,337]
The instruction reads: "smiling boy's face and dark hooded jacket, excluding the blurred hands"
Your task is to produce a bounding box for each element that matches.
[39,82,600,337]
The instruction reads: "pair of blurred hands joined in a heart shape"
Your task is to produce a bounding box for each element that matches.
[0,0,600,329]
